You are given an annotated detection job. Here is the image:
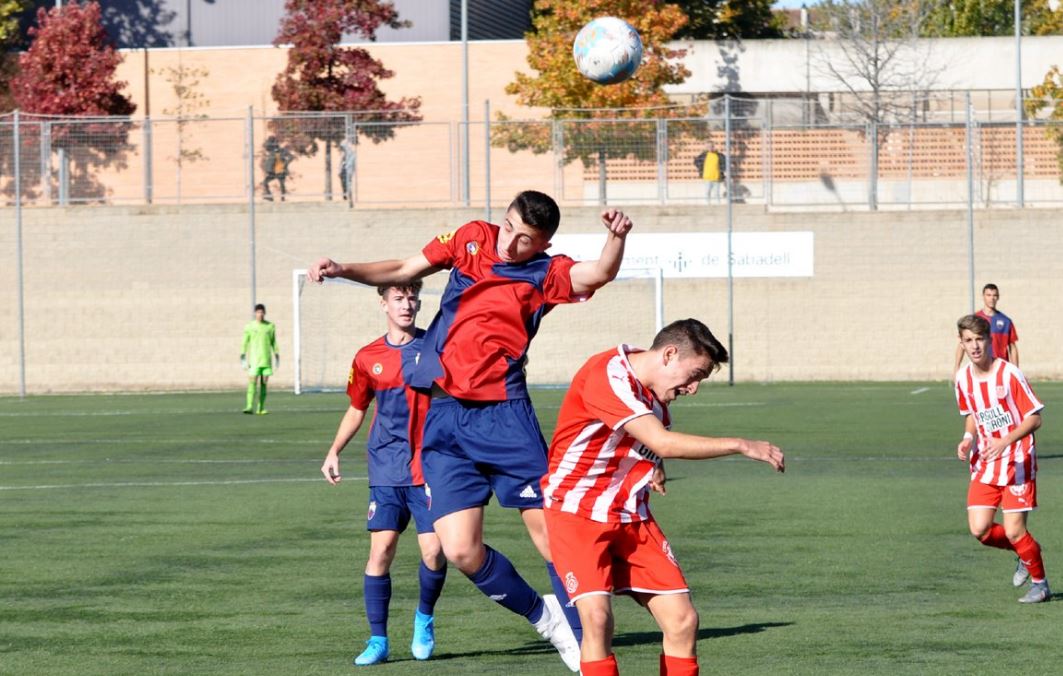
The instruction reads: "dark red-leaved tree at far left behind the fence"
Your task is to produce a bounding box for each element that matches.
[12,2,136,199]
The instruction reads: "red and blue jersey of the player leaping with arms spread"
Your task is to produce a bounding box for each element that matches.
[411,221,590,402]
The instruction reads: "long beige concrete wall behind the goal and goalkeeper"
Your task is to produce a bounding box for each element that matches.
[0,204,1063,392]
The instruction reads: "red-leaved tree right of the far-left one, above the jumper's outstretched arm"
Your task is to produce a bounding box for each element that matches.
[271,0,421,197]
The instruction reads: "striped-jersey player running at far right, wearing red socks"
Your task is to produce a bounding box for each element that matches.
[956,315,1051,604]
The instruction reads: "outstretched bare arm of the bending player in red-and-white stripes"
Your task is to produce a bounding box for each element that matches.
[624,416,786,472]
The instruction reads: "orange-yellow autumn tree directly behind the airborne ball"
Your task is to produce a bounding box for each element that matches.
[492,0,690,179]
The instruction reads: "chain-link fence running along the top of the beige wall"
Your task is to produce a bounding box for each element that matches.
[0,92,1063,209]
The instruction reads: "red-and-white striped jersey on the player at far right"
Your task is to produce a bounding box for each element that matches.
[956,359,1045,486]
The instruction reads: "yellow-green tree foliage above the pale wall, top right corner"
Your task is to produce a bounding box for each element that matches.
[923,0,1063,37]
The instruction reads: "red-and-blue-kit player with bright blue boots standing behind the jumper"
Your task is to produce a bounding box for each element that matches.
[321,282,446,666]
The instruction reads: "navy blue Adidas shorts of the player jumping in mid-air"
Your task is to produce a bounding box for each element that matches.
[421,398,546,519]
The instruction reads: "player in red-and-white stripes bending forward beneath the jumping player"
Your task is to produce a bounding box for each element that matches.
[542,319,783,676]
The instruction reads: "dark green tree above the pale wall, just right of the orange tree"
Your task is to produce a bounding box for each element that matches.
[674,0,786,40]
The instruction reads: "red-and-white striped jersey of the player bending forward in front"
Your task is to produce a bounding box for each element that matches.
[542,345,672,523]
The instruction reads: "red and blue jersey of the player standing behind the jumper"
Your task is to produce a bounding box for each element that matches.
[347,329,431,486]
